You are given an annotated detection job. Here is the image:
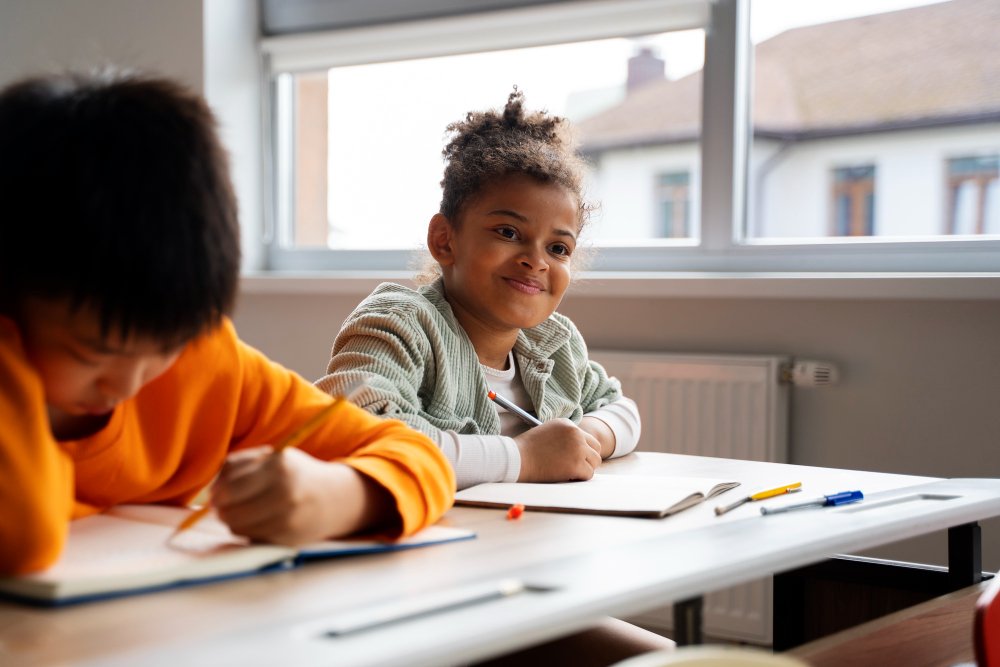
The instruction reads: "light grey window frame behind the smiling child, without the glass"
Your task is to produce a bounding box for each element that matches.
[261,0,1000,275]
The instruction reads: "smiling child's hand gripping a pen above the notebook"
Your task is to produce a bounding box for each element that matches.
[514,419,601,482]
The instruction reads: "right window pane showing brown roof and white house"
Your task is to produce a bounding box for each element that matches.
[745,0,1000,242]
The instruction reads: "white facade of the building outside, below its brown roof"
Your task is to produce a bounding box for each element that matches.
[588,123,1000,241]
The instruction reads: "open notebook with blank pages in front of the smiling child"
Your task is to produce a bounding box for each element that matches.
[455,473,739,518]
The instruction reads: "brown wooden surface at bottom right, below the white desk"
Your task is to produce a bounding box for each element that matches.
[788,583,987,667]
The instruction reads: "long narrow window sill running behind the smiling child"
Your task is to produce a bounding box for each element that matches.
[240,271,1000,300]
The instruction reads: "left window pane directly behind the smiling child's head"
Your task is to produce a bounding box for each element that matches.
[277,30,704,249]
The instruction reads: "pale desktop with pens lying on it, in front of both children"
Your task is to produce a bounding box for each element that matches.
[0,453,1000,667]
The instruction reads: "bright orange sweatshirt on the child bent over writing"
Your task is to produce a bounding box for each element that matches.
[0,318,455,574]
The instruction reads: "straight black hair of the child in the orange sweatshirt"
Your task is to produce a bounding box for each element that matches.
[0,70,240,345]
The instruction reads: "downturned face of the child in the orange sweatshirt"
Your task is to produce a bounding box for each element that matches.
[19,298,183,417]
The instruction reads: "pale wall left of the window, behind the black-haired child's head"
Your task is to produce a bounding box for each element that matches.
[0,0,263,268]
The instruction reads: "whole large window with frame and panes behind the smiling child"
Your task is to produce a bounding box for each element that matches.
[262,0,1000,271]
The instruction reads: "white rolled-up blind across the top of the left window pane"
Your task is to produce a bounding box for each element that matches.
[261,0,711,73]
